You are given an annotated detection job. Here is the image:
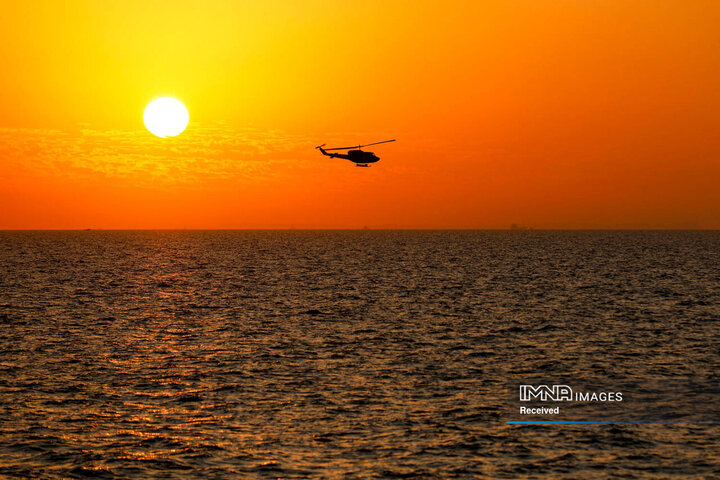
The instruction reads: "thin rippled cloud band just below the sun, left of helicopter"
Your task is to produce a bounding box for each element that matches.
[0,124,312,184]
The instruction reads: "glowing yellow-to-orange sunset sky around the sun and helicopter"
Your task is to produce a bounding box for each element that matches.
[0,0,720,229]
